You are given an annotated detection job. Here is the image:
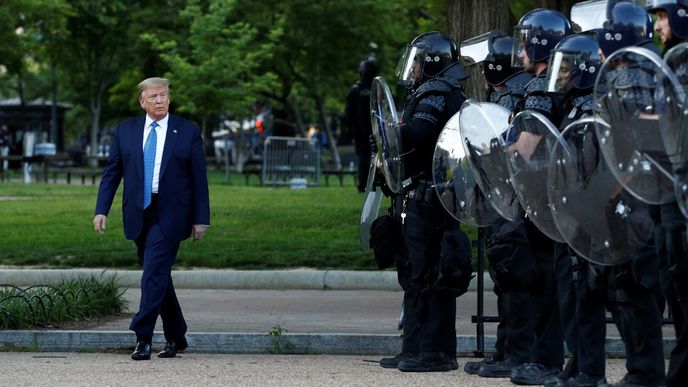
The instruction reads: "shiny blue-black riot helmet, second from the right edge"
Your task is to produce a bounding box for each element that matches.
[599,1,653,56]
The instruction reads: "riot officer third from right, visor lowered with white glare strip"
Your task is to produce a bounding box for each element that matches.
[545,32,607,387]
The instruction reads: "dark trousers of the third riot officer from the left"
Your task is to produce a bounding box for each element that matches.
[526,221,564,367]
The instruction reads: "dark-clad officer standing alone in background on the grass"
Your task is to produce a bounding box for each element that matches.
[344,59,378,192]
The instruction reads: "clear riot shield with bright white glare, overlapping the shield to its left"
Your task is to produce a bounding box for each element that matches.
[459,99,521,220]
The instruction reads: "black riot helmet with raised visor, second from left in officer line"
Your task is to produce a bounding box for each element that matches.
[459,30,518,85]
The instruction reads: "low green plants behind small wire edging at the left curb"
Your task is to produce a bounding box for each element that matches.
[0,275,126,329]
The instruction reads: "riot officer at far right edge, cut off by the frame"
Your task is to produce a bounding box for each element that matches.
[647,0,688,386]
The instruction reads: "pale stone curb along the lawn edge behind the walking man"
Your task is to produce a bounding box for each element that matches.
[0,269,492,291]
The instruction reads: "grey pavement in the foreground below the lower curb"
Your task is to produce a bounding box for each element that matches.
[0,353,624,387]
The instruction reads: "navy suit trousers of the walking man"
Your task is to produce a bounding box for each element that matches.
[129,199,186,343]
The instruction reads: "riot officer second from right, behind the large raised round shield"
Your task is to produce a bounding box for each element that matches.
[597,2,665,386]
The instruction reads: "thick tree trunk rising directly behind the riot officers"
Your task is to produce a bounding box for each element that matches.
[447,0,516,101]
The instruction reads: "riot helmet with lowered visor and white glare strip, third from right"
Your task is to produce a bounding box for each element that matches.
[546,32,602,93]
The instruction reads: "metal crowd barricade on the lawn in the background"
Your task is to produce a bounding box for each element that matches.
[262,136,320,186]
